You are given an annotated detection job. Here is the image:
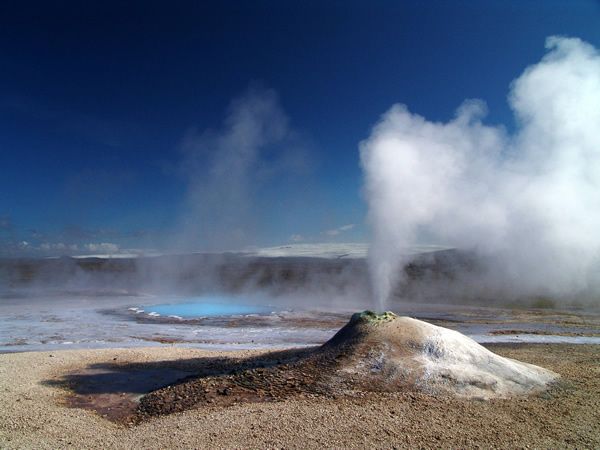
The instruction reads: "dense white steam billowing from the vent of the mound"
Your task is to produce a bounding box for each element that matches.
[360,37,600,306]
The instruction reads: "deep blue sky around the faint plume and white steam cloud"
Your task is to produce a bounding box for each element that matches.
[0,0,600,255]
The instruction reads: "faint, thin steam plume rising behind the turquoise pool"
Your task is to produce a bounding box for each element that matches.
[178,87,304,250]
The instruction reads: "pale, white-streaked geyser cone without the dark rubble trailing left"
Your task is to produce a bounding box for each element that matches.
[320,311,558,398]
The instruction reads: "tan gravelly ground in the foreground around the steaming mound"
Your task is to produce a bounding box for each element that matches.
[0,344,600,449]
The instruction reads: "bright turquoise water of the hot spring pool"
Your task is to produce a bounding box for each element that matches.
[144,296,273,318]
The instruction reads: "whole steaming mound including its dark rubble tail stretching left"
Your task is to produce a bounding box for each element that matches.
[137,311,558,420]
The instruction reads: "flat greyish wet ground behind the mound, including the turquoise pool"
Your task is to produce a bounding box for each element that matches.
[0,293,600,352]
